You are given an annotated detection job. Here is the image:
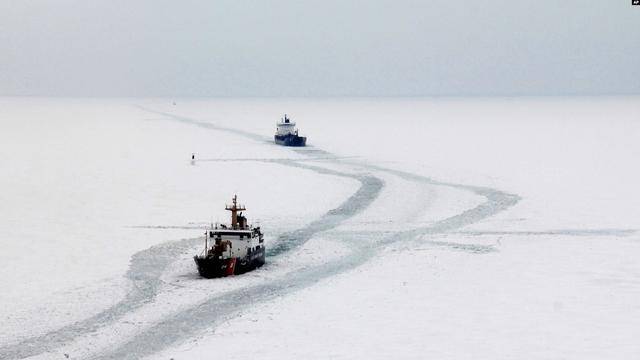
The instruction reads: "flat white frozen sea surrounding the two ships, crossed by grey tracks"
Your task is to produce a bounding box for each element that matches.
[0,97,640,359]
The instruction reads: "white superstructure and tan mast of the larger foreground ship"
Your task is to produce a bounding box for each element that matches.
[205,196,263,259]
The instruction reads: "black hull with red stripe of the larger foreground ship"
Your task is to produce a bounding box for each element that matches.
[193,247,265,279]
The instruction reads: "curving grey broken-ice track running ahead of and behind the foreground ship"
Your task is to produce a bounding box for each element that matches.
[0,153,383,359]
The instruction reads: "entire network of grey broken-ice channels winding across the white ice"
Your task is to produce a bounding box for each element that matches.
[0,109,519,359]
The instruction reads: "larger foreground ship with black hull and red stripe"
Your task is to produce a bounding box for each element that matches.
[193,196,265,278]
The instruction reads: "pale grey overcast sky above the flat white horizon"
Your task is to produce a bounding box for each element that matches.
[0,0,640,97]
